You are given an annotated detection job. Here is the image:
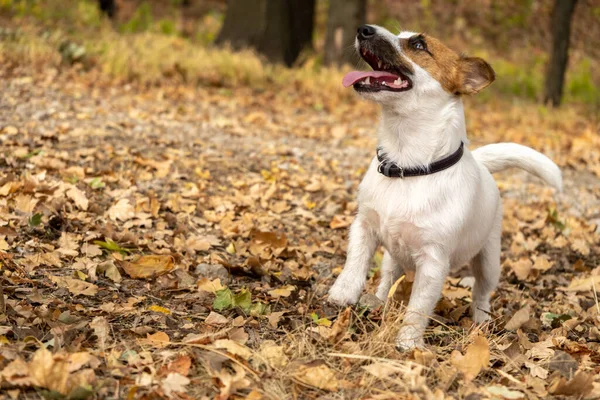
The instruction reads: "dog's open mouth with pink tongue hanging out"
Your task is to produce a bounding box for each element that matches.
[342,49,412,92]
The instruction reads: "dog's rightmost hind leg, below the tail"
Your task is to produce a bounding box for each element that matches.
[471,204,502,323]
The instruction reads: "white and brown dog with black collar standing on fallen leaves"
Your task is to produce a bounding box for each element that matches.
[328,25,562,350]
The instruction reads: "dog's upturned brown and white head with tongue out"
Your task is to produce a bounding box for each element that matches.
[343,25,495,108]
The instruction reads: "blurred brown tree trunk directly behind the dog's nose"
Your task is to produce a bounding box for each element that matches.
[325,0,367,65]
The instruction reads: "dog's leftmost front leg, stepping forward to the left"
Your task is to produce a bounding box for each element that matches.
[329,213,378,305]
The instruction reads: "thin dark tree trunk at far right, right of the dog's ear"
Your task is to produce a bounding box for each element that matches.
[544,0,577,107]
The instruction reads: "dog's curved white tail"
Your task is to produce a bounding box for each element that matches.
[472,143,562,191]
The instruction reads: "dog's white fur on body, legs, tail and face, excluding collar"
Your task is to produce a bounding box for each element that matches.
[329,27,562,349]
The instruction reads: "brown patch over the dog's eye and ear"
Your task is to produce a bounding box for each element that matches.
[400,34,496,94]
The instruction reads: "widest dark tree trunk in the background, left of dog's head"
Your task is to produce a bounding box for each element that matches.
[215,0,315,66]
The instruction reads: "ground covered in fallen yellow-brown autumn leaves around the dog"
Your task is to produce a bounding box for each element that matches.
[0,59,600,399]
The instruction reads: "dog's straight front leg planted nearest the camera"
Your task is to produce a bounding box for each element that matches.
[396,248,450,350]
